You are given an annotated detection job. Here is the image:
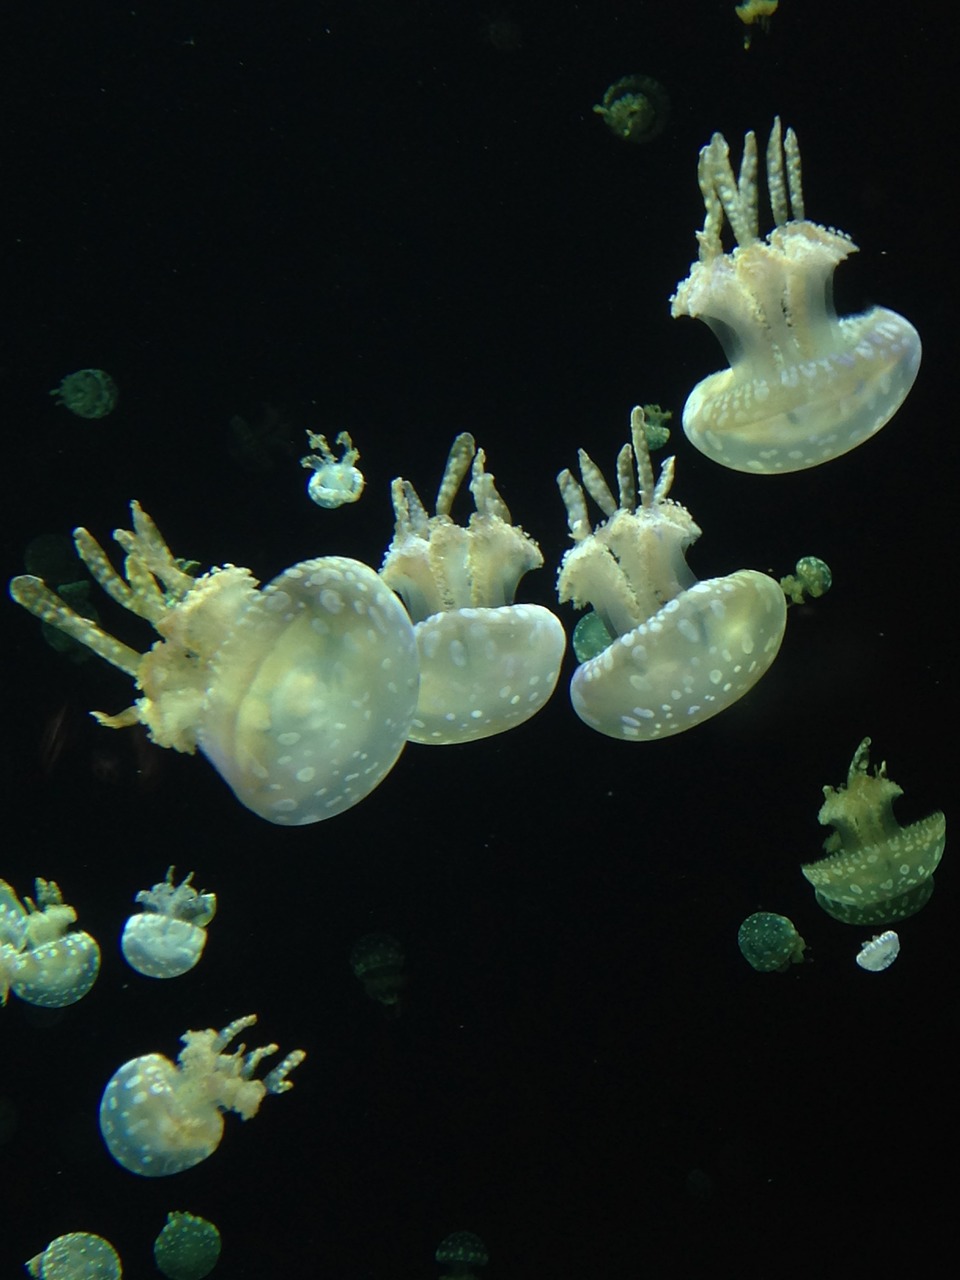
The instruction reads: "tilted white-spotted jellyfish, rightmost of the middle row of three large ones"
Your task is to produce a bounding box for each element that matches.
[557,407,787,742]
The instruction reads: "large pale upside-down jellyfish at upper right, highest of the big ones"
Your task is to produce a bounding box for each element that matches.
[671,118,920,475]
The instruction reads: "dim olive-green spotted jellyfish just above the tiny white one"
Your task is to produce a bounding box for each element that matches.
[801,737,946,924]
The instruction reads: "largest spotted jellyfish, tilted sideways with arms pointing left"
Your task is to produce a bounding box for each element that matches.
[10,502,419,826]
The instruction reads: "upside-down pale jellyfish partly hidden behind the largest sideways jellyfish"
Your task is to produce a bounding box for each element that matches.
[380,433,566,745]
